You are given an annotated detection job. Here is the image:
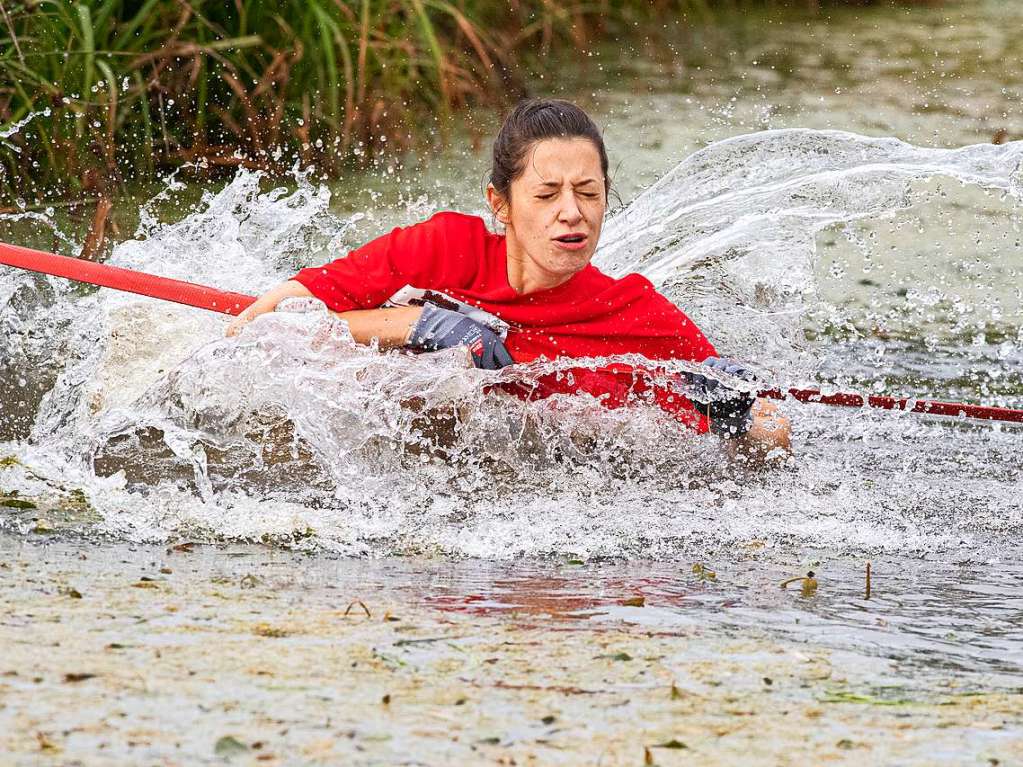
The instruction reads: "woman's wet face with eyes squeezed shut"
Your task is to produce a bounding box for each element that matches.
[487,138,608,284]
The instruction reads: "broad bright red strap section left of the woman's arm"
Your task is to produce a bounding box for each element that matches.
[0,242,256,314]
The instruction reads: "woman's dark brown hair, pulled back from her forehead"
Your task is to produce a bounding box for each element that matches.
[490,98,611,200]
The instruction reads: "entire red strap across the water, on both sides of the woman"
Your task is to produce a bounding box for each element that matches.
[0,242,1023,423]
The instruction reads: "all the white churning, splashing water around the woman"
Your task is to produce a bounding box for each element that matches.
[0,130,1023,559]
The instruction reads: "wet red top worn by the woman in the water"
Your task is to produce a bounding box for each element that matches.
[295,213,716,432]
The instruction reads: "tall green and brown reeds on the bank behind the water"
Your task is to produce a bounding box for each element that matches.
[0,0,937,198]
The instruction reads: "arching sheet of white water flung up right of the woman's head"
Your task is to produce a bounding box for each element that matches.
[594,129,1023,377]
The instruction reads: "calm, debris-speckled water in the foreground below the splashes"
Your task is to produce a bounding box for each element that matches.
[0,539,1023,765]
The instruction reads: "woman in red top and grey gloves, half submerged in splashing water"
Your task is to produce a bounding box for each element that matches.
[227,99,789,454]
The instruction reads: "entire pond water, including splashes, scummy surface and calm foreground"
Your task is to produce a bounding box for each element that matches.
[0,2,1023,764]
